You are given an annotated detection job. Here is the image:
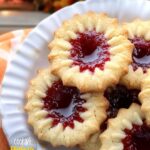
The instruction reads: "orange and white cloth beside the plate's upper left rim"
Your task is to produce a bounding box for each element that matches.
[0,29,31,84]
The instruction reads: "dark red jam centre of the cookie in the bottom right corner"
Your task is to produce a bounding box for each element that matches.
[122,123,150,150]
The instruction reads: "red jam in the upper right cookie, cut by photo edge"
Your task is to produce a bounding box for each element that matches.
[130,37,150,73]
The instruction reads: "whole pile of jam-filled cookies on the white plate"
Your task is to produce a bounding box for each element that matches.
[25,12,150,150]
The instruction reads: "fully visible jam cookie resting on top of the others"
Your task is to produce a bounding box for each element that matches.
[49,12,133,92]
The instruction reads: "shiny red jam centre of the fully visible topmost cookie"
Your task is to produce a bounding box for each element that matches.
[70,31,110,72]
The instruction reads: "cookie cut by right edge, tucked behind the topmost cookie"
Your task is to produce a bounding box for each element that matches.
[121,20,150,89]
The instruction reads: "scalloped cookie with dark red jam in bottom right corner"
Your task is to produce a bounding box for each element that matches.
[100,103,150,150]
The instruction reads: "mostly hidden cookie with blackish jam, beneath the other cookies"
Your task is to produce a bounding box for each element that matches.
[80,84,140,150]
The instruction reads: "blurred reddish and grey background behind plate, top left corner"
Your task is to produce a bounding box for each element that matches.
[0,0,82,34]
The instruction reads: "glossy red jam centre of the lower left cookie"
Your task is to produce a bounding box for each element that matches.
[43,81,86,128]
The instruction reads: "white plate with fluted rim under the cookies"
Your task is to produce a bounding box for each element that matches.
[0,0,150,150]
